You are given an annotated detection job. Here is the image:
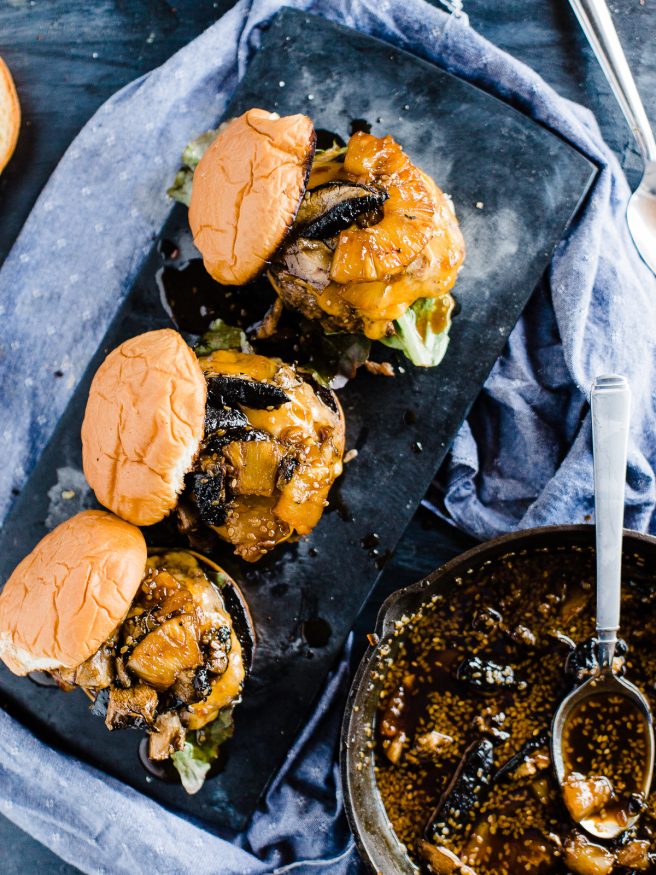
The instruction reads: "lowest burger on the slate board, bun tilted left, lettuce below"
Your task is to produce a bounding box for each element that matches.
[0,510,255,793]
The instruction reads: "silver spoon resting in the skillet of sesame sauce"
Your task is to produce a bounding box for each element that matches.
[551,376,654,839]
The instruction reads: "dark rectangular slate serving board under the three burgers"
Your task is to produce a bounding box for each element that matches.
[0,10,596,828]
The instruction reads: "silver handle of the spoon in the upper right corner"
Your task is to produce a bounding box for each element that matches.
[570,0,656,161]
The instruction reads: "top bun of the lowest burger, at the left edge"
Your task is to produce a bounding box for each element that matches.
[0,510,147,675]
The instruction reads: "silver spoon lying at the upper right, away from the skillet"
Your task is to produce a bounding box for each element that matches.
[570,0,656,273]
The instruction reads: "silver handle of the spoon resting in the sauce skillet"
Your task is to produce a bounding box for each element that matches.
[590,376,631,670]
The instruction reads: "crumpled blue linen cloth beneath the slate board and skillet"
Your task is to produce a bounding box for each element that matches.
[0,0,656,875]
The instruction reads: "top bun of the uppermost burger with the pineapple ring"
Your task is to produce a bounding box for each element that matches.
[189,109,316,286]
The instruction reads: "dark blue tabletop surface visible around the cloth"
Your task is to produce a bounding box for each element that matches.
[0,0,656,875]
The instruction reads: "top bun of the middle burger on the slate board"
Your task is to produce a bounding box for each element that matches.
[82,328,207,526]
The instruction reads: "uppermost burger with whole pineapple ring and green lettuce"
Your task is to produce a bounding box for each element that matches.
[169,109,465,366]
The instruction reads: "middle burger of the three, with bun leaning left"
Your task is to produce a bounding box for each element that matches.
[82,329,344,562]
